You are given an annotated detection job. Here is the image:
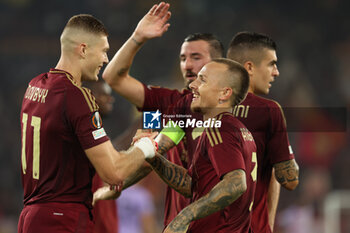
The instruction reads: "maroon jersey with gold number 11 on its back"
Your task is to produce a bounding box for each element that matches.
[21,69,109,207]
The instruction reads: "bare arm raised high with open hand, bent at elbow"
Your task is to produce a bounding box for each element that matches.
[102,2,171,107]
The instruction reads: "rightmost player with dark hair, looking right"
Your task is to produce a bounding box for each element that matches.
[227,32,299,233]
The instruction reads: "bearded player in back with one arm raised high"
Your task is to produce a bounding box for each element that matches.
[103,3,224,226]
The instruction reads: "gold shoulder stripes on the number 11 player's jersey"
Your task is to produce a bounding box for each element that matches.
[50,71,99,112]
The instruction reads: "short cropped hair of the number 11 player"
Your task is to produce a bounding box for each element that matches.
[65,14,108,36]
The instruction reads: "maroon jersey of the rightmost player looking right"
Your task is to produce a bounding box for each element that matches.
[233,93,294,233]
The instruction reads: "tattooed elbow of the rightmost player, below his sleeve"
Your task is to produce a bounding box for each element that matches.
[273,159,299,190]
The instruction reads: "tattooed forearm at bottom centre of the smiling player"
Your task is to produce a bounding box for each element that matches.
[164,169,247,232]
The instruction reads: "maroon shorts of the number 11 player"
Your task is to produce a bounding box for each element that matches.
[18,202,93,233]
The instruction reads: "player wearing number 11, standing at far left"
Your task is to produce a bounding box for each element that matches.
[18,15,155,233]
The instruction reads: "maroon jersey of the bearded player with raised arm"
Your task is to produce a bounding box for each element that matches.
[140,85,191,226]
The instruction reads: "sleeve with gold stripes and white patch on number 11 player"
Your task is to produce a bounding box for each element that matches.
[66,87,109,150]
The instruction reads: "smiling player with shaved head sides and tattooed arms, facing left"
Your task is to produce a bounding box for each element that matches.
[147,58,258,233]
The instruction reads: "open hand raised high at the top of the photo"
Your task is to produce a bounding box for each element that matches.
[133,2,171,43]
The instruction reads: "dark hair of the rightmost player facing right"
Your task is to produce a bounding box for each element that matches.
[227,31,277,64]
